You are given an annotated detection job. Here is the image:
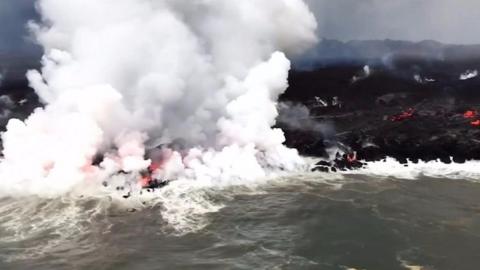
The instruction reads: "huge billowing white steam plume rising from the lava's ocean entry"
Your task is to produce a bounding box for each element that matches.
[0,0,316,196]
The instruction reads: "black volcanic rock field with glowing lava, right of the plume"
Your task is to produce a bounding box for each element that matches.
[281,49,480,168]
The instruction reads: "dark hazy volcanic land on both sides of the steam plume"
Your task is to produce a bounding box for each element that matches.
[0,40,480,170]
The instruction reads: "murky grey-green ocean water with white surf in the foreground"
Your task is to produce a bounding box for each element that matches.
[0,169,480,270]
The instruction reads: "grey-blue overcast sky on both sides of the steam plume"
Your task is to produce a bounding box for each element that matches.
[0,0,480,54]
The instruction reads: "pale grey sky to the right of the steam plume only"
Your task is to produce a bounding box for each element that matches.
[307,0,480,44]
